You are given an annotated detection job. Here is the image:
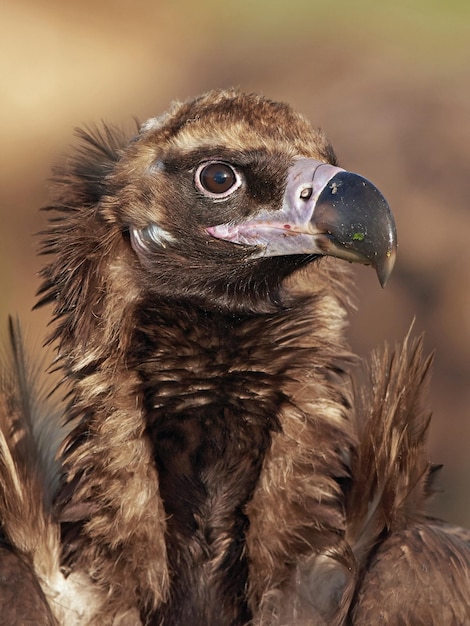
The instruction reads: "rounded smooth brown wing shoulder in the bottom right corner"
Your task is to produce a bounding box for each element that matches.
[351,520,470,626]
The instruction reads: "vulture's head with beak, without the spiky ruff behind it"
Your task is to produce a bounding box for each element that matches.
[102,92,396,310]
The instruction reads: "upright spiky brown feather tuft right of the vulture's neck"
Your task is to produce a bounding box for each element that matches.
[346,328,433,558]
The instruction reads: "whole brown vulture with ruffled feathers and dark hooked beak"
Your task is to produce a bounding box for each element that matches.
[0,90,470,626]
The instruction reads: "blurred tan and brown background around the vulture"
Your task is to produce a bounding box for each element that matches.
[0,0,470,526]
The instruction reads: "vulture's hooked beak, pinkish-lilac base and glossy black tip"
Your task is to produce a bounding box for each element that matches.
[207,158,397,287]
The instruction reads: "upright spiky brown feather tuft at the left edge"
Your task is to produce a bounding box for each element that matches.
[0,318,63,554]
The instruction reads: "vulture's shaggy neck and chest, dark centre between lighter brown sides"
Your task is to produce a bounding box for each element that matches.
[58,282,351,625]
